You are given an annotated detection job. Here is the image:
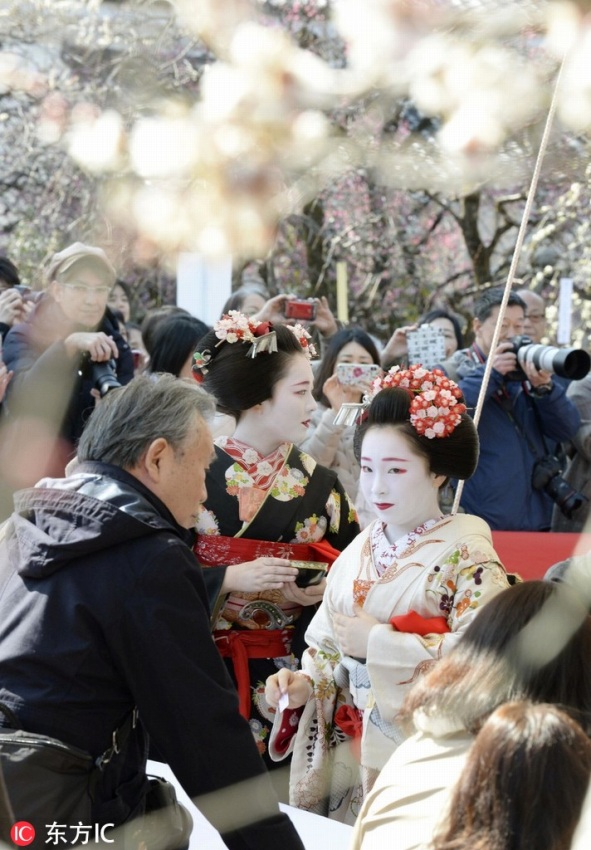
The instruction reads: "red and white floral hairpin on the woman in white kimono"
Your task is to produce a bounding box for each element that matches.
[364,364,466,440]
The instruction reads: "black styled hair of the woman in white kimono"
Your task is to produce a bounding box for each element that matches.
[354,387,479,479]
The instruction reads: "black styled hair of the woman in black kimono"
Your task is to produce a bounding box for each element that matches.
[197,323,305,421]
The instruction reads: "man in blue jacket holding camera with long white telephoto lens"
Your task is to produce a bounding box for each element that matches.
[442,288,580,531]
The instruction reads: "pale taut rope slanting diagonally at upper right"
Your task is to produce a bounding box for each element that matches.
[451,59,564,514]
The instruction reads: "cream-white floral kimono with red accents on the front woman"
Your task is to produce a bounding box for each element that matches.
[270,514,508,823]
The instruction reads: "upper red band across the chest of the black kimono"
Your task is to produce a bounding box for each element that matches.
[194,534,341,567]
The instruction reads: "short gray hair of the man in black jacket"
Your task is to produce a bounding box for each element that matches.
[78,374,215,469]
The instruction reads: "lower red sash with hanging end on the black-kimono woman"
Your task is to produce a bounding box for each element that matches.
[213,629,290,720]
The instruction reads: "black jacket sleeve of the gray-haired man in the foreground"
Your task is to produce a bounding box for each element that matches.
[109,541,302,850]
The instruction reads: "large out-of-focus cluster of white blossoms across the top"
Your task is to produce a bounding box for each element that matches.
[56,0,591,256]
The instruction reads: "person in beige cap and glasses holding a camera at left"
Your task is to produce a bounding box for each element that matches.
[2,242,133,476]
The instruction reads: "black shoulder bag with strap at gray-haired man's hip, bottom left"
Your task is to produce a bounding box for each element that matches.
[0,703,137,825]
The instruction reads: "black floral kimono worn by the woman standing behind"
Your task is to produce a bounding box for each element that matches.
[195,437,359,767]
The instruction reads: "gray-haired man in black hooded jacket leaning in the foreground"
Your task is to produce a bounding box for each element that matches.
[0,375,302,850]
